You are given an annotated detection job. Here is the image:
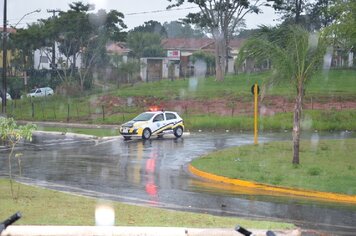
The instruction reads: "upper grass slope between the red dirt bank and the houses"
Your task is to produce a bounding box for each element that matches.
[117,70,356,99]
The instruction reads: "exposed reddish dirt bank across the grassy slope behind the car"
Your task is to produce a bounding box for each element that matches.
[95,95,356,116]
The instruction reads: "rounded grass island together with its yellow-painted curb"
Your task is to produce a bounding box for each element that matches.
[188,138,356,204]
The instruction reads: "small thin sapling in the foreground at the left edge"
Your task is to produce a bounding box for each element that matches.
[0,117,36,199]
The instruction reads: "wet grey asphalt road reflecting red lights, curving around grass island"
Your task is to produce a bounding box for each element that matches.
[0,132,356,235]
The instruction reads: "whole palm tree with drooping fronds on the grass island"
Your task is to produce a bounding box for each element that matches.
[239,25,326,164]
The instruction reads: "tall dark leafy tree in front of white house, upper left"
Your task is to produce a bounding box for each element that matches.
[43,2,126,90]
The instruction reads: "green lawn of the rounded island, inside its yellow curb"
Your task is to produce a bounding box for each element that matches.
[192,139,356,195]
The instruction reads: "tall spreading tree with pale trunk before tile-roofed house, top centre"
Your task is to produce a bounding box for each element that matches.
[168,0,265,81]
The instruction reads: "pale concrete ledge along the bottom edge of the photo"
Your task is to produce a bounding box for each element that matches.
[1,226,302,236]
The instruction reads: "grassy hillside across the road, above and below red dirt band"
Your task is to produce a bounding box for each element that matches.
[7,70,356,130]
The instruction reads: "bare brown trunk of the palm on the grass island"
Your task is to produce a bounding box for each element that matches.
[292,84,303,165]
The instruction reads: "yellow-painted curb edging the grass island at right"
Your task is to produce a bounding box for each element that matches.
[188,164,356,204]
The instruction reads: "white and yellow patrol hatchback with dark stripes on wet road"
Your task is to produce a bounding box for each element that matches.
[120,111,184,140]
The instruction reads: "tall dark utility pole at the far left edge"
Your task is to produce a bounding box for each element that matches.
[1,0,7,114]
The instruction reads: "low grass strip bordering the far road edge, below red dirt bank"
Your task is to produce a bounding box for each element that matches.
[28,110,356,137]
